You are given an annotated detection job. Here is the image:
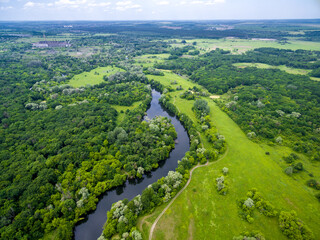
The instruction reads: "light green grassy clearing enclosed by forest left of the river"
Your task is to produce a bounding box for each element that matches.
[68,66,124,87]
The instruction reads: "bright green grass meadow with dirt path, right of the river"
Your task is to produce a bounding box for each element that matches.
[139,68,320,240]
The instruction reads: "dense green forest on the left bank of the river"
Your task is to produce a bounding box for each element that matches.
[0,35,176,239]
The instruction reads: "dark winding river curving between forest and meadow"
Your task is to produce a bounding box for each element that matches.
[74,90,190,240]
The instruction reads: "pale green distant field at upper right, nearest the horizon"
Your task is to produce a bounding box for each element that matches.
[172,38,320,54]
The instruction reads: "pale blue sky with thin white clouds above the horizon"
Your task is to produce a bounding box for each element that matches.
[0,0,320,21]
